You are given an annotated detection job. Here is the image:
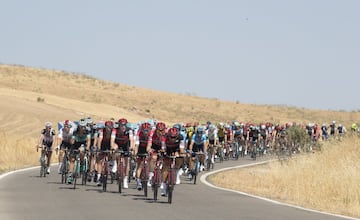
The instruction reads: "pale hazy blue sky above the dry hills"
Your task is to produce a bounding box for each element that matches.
[0,0,360,111]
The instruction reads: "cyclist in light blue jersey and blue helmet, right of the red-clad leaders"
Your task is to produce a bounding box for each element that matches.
[189,126,208,179]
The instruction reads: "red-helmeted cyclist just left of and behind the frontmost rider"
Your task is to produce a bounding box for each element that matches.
[148,122,166,186]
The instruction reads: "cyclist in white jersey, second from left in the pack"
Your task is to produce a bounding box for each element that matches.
[57,120,73,174]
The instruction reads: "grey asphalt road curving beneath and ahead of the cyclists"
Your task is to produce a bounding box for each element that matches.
[0,159,351,220]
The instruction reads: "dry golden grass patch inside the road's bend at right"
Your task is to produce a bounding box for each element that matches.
[210,137,360,217]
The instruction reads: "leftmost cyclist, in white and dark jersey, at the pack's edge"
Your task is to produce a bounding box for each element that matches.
[38,122,56,174]
